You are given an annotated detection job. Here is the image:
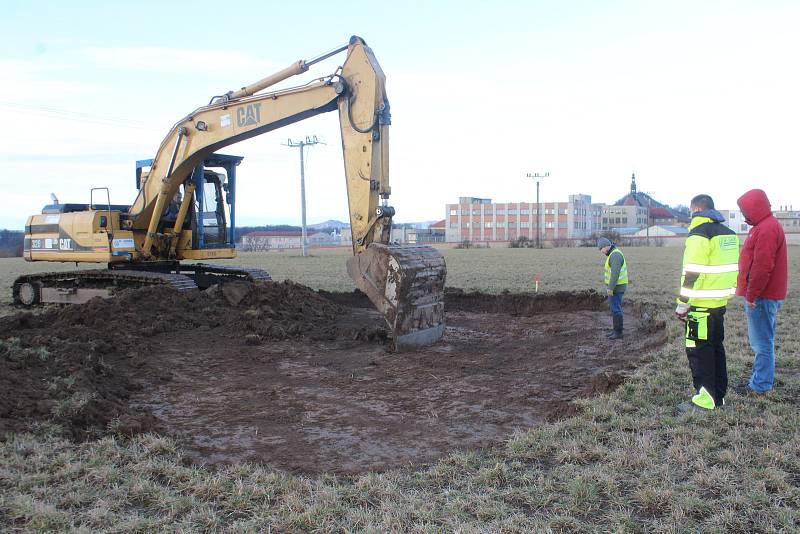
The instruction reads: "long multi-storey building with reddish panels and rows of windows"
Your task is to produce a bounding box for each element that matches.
[445,194,602,243]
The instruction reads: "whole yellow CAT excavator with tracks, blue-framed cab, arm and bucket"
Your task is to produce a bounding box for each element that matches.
[13,36,446,349]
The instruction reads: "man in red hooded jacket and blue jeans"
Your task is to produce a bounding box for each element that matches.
[734,189,788,394]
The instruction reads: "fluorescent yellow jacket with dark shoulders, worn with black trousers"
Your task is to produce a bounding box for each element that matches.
[678,212,739,308]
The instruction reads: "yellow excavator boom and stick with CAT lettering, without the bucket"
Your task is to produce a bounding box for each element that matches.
[128,37,394,259]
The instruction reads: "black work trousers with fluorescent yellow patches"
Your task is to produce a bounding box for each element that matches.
[686,306,728,406]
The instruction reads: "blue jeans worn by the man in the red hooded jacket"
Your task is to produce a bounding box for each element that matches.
[744,298,783,392]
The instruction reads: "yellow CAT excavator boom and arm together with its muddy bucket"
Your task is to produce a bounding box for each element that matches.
[126,37,446,348]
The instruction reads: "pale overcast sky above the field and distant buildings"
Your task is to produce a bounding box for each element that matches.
[0,0,800,229]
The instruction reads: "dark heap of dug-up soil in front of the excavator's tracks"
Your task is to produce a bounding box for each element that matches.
[0,281,386,439]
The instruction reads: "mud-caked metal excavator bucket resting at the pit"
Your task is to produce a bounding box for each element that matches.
[347,243,447,350]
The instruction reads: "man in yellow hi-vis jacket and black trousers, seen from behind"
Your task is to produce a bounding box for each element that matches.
[675,195,739,412]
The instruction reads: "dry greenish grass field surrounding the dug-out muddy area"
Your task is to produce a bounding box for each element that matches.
[0,247,800,533]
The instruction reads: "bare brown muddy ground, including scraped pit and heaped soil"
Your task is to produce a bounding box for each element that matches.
[0,282,665,473]
